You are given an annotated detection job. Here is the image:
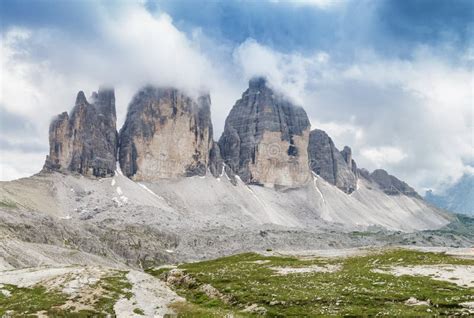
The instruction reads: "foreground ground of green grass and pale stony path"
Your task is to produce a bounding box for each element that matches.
[0,247,474,317]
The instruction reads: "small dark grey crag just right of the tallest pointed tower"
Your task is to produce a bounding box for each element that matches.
[308,129,357,193]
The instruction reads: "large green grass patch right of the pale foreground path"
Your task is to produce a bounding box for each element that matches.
[151,249,474,317]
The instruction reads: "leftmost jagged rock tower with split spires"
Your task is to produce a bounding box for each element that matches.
[43,88,117,177]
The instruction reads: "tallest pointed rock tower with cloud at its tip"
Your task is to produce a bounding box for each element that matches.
[219,77,310,187]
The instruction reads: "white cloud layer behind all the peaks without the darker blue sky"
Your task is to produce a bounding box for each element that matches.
[0,1,474,194]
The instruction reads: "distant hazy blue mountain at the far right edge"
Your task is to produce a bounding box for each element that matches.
[425,174,474,215]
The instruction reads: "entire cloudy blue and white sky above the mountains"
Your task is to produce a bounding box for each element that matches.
[0,0,474,192]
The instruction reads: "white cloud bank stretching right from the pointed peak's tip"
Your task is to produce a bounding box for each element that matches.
[234,40,474,188]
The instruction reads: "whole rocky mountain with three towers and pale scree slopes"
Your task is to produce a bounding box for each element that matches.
[0,78,462,267]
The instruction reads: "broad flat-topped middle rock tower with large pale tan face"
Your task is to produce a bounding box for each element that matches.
[119,86,213,181]
